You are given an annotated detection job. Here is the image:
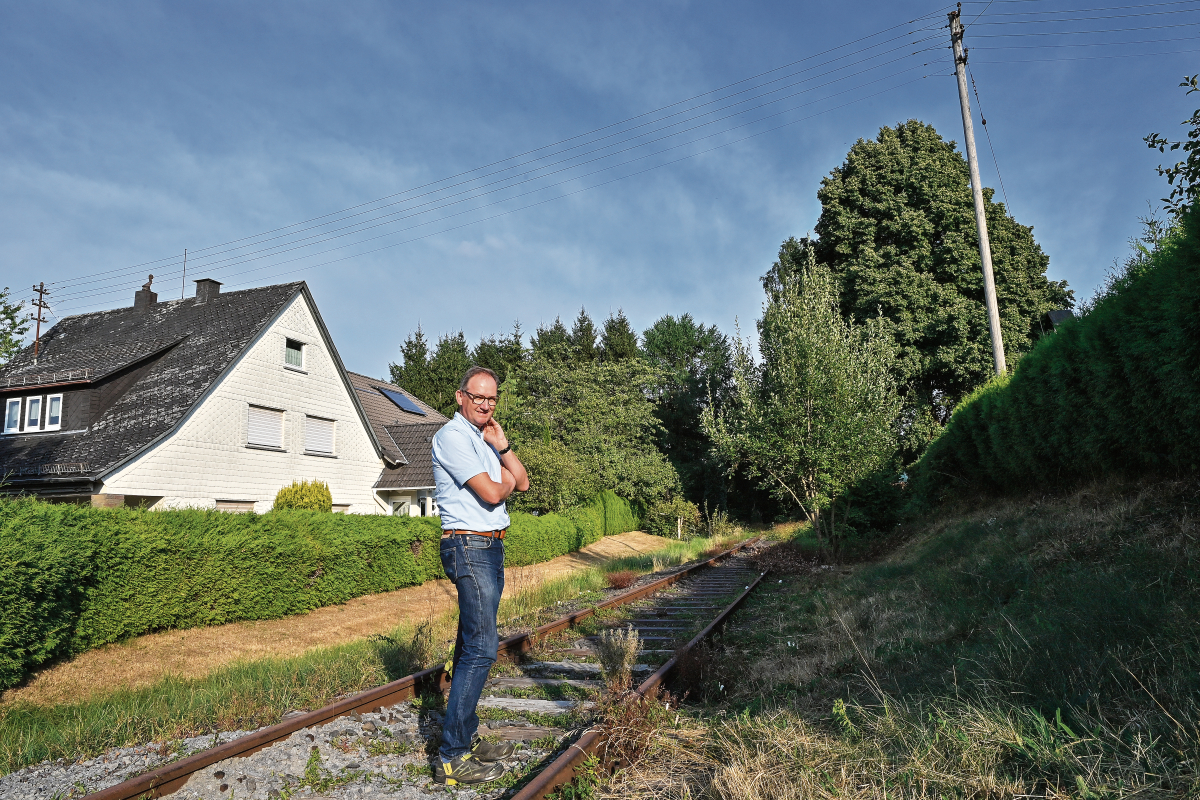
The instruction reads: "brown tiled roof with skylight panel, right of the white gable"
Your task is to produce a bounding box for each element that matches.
[347,372,450,489]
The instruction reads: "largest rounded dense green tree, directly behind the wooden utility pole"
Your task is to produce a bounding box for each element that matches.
[811,120,1074,443]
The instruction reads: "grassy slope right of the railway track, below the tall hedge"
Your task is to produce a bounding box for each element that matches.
[601,483,1200,800]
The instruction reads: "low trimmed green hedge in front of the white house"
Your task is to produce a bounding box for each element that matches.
[0,495,636,688]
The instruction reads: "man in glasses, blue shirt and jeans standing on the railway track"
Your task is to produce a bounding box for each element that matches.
[433,367,529,786]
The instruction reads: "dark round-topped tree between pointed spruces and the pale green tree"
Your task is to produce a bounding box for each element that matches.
[642,314,733,509]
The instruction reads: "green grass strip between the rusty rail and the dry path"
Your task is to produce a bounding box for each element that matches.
[0,539,748,774]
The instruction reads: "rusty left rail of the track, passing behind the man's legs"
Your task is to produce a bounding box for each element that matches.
[82,536,761,800]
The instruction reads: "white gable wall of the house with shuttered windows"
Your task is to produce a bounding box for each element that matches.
[103,294,386,513]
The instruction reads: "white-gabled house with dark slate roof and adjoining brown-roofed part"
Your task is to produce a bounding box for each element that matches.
[0,279,446,515]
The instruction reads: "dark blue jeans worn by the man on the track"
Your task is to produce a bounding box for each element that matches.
[438,534,504,762]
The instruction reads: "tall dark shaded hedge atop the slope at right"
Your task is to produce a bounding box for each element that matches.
[912,211,1200,500]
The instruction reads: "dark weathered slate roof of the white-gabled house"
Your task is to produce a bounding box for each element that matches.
[0,282,316,479]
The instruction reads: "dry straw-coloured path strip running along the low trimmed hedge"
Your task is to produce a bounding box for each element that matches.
[0,531,666,705]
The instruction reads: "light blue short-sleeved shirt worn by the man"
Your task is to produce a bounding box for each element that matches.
[433,411,509,530]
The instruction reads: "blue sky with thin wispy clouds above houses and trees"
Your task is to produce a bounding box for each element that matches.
[0,0,1200,375]
